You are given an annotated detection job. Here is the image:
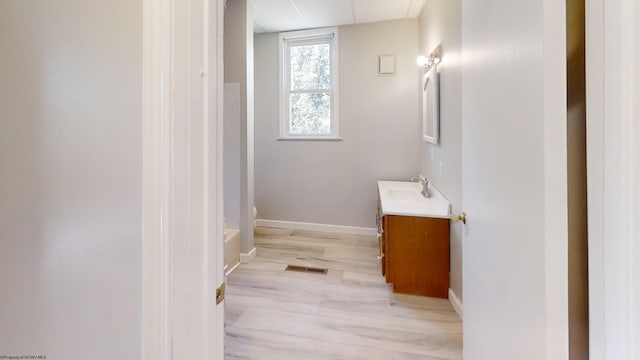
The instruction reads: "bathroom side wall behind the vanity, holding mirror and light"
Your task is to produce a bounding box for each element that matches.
[418,0,463,300]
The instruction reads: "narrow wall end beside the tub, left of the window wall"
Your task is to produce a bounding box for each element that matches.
[224,0,254,254]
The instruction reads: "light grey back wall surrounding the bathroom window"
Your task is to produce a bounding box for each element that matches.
[255,20,419,227]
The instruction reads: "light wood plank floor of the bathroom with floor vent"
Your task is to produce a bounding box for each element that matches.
[225,228,462,360]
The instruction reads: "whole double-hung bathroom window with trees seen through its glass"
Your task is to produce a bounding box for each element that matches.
[280,28,339,140]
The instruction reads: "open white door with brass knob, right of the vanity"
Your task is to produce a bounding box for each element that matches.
[455,0,568,360]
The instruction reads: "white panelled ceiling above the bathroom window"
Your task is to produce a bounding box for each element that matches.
[253,0,426,33]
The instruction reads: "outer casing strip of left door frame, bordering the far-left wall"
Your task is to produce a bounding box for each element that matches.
[142,0,173,360]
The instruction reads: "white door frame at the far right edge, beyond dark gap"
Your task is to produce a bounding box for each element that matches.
[586,0,640,359]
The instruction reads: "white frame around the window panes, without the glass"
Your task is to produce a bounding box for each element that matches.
[278,27,341,140]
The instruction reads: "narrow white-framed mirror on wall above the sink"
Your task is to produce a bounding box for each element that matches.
[422,65,440,144]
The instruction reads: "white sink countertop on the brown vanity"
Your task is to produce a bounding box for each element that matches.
[378,180,451,219]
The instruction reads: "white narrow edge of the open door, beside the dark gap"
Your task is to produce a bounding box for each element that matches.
[542,0,569,360]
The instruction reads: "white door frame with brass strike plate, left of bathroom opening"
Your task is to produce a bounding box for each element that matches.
[142,0,224,360]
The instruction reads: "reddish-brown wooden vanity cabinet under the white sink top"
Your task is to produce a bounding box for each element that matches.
[378,214,449,298]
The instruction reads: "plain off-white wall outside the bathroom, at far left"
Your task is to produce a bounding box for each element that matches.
[0,0,142,360]
